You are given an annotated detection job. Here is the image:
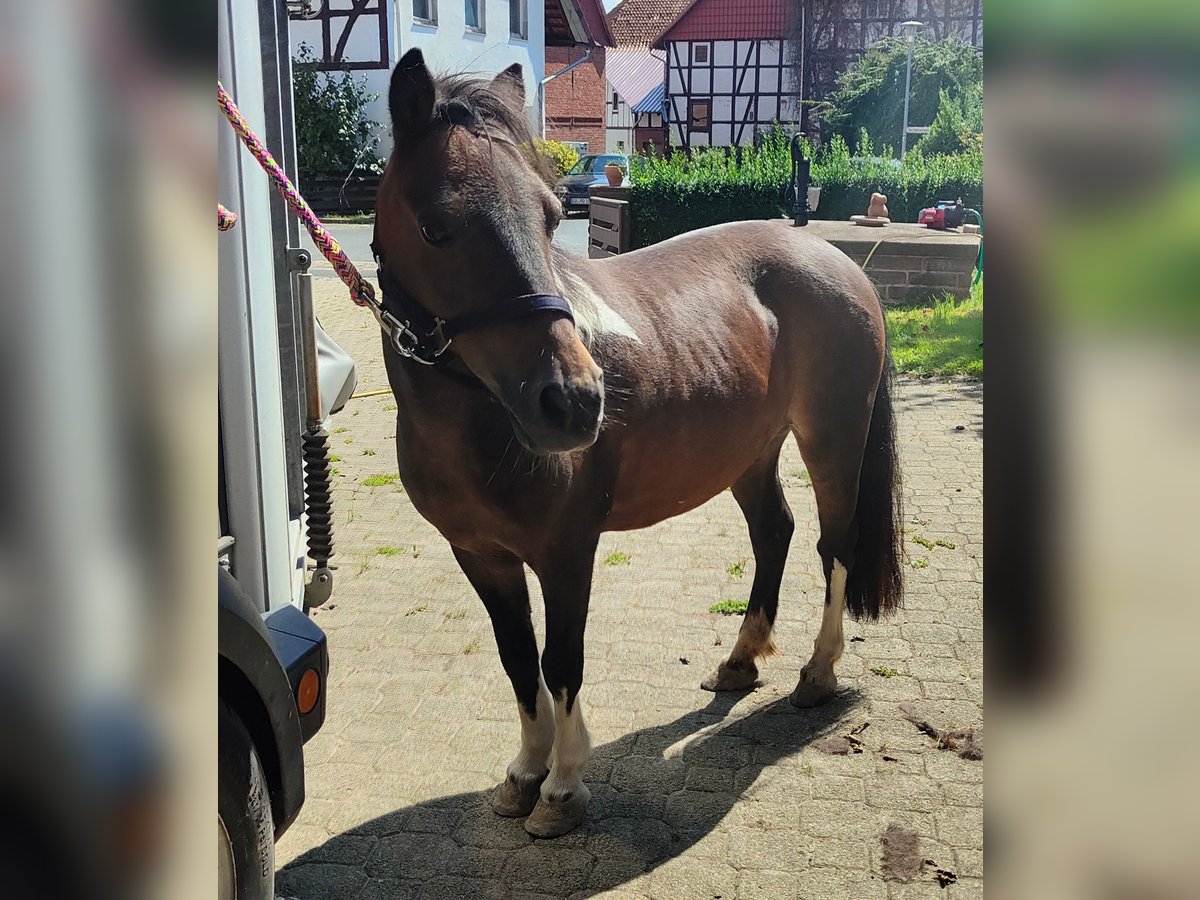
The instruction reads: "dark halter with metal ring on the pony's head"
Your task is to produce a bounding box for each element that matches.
[371,241,575,366]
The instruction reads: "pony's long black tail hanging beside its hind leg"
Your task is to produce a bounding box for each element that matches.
[846,353,904,620]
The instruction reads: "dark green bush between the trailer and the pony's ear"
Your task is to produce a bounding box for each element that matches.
[292,43,383,186]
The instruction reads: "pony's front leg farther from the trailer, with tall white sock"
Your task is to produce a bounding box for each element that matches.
[526,540,595,838]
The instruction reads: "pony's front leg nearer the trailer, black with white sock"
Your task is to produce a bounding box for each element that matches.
[454,548,554,817]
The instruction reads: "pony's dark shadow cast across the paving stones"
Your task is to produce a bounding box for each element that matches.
[276,691,859,900]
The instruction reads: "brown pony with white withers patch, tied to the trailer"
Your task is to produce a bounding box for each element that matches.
[374,49,902,836]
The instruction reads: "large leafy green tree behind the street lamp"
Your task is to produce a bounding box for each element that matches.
[815,37,983,155]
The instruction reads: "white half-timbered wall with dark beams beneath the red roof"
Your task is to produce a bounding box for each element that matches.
[666,41,800,146]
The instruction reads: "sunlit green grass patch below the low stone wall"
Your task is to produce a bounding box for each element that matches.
[887,280,983,378]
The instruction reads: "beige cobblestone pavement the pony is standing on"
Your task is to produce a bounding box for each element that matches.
[277,269,983,900]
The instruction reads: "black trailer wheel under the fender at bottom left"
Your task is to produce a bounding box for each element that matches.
[217,701,275,900]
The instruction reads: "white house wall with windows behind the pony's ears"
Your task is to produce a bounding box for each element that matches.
[290,0,546,157]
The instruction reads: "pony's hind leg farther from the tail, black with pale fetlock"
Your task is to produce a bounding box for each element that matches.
[700,431,796,691]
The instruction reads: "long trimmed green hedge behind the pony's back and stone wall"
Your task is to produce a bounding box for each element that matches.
[630,131,983,248]
